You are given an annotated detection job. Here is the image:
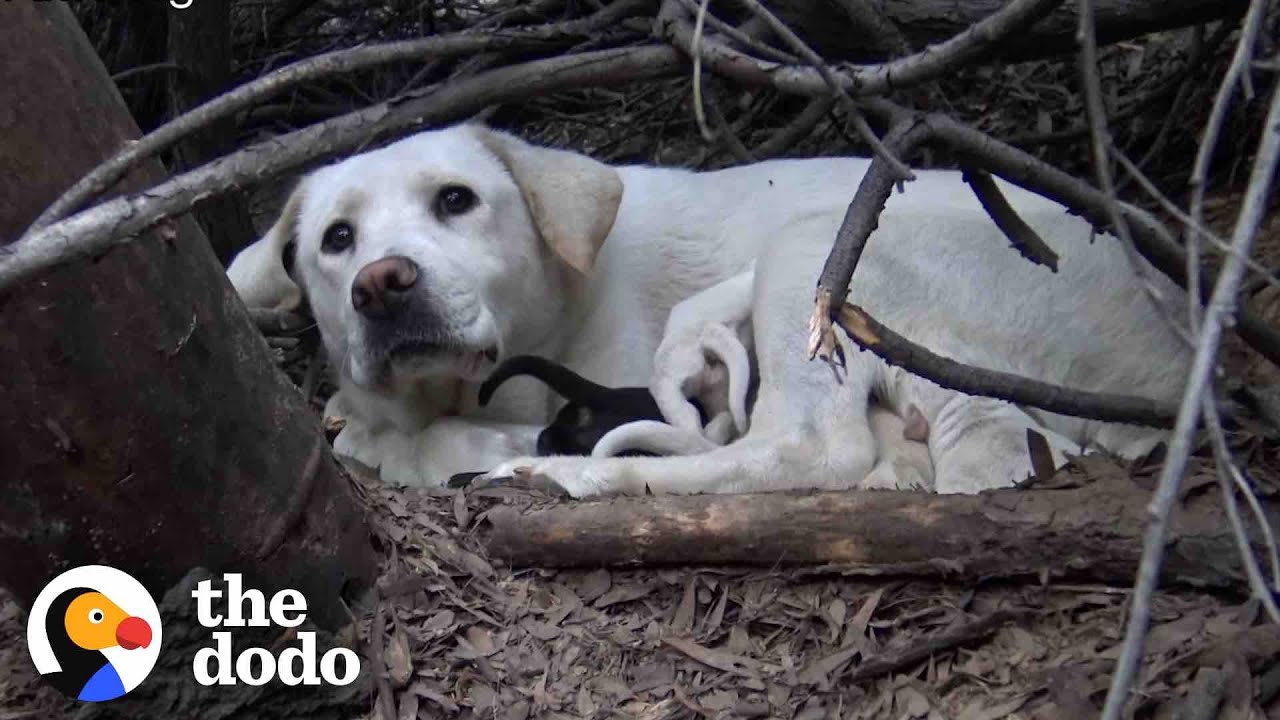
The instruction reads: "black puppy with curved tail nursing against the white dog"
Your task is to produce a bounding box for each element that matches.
[480,355,707,456]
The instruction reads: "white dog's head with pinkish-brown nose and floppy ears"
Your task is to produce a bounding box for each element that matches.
[235,126,622,389]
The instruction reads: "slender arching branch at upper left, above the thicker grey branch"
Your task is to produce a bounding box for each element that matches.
[23,0,653,237]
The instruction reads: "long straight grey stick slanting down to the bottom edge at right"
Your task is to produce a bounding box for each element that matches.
[1102,74,1280,720]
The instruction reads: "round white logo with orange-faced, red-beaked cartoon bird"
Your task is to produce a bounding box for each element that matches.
[27,565,160,702]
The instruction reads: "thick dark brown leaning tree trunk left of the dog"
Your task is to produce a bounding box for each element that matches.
[0,3,378,626]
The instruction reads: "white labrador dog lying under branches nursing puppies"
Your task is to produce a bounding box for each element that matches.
[228,126,1188,496]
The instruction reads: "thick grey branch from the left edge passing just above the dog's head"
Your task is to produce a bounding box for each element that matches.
[0,46,684,291]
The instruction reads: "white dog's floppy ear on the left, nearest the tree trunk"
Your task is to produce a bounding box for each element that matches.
[227,188,302,310]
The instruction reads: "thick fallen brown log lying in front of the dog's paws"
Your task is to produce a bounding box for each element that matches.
[481,461,1276,588]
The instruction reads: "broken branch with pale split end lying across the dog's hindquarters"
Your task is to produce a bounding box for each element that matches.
[836,302,1178,428]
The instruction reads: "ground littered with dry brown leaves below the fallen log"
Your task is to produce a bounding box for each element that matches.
[0,445,1280,720]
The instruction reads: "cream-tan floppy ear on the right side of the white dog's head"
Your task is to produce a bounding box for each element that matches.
[476,128,622,273]
